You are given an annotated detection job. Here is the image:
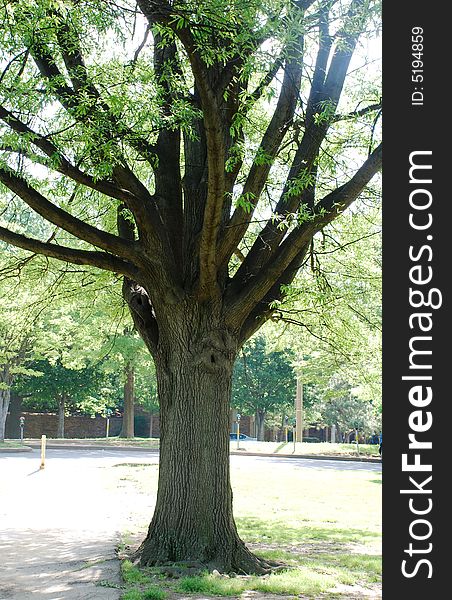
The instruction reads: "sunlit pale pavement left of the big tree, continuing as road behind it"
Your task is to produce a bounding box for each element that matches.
[0,449,381,600]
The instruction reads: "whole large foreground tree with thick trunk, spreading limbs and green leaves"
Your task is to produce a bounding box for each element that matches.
[0,0,381,571]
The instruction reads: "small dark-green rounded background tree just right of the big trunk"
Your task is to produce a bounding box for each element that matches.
[232,336,296,441]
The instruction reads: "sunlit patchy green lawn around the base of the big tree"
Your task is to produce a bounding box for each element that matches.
[110,454,381,600]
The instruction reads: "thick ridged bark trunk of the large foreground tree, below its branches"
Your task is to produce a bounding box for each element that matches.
[132,307,269,573]
